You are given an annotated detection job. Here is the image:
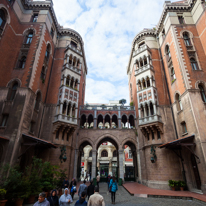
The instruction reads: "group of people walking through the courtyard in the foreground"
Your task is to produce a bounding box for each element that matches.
[34,176,118,206]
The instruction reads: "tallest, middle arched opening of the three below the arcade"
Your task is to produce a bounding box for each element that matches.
[96,137,119,182]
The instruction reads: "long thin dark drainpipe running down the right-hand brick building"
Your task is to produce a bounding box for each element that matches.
[157,36,187,182]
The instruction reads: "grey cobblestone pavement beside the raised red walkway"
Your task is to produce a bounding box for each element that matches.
[72,183,206,206]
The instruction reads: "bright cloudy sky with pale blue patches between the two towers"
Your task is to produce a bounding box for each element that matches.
[53,0,171,103]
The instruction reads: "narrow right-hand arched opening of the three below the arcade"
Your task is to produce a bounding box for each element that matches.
[123,141,138,181]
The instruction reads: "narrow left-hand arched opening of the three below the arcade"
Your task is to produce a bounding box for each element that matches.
[76,141,92,181]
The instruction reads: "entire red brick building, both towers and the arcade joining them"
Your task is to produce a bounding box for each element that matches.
[0,0,206,193]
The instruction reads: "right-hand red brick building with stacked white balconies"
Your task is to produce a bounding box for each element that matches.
[127,0,206,193]
